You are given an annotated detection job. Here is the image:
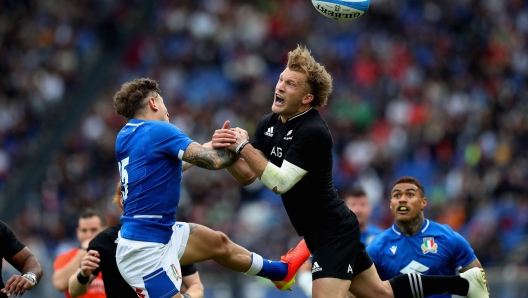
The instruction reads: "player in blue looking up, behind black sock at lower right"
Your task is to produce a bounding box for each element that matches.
[367,177,488,298]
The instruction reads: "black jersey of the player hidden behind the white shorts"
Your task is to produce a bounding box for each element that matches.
[88,224,196,298]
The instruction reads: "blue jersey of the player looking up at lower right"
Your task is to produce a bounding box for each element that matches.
[367,219,476,298]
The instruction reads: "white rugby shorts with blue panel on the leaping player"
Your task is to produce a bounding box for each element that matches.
[116,222,189,298]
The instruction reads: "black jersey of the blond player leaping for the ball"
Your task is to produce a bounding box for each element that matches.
[251,109,350,239]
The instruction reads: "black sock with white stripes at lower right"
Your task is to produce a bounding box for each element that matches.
[389,273,469,298]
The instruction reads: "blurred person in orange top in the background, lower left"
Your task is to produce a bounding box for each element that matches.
[52,210,106,298]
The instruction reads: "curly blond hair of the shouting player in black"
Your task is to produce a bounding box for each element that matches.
[287,45,332,108]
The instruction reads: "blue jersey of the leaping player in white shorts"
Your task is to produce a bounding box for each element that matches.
[115,119,193,244]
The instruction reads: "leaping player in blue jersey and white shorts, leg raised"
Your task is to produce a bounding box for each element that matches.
[114,79,296,298]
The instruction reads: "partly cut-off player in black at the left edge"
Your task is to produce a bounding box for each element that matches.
[0,221,44,298]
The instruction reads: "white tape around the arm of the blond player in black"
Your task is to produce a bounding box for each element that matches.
[260,160,308,195]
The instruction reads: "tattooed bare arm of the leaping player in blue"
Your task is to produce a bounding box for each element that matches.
[182,143,238,170]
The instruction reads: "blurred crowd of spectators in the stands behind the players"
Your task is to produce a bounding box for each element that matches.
[0,0,528,286]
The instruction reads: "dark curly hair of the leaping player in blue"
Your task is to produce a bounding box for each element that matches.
[114,78,161,120]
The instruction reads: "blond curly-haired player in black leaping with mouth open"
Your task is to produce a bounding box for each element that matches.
[212,46,488,298]
